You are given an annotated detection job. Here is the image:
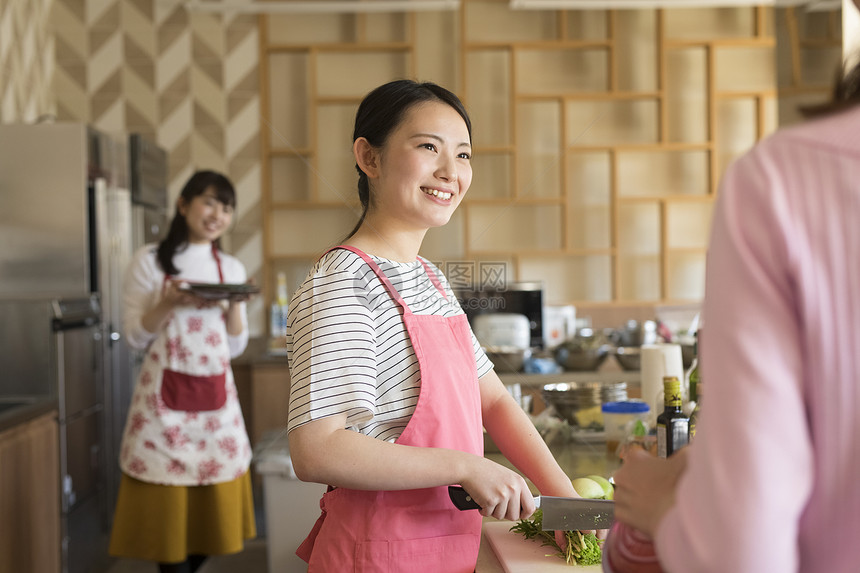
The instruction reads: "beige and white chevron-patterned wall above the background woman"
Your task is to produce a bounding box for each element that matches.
[49,0,265,336]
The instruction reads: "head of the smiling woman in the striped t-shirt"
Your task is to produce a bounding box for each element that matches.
[340,82,472,260]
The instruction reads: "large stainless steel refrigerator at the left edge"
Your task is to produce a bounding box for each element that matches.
[0,123,133,573]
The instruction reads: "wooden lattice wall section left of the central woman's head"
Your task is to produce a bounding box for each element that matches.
[260,13,440,318]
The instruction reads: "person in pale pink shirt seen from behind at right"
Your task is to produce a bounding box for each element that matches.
[604,13,860,573]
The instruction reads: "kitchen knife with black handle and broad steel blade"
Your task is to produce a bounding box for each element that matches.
[448,485,615,531]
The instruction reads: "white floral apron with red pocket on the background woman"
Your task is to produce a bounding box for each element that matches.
[120,246,251,486]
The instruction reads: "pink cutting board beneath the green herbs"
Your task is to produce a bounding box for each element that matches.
[484,521,603,573]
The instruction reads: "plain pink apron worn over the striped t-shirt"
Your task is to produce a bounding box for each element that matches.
[296,246,484,573]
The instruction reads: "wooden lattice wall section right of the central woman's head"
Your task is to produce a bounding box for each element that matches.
[462,0,776,308]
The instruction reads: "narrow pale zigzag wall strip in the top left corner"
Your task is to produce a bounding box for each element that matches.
[0,0,54,123]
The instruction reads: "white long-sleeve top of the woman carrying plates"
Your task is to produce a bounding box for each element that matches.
[123,244,248,358]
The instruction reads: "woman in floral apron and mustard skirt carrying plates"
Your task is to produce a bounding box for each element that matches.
[110,171,256,573]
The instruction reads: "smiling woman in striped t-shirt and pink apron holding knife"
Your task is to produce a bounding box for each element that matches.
[287,80,588,572]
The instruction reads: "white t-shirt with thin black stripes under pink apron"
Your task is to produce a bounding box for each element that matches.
[287,249,493,441]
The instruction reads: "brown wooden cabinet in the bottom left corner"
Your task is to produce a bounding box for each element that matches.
[0,412,60,573]
